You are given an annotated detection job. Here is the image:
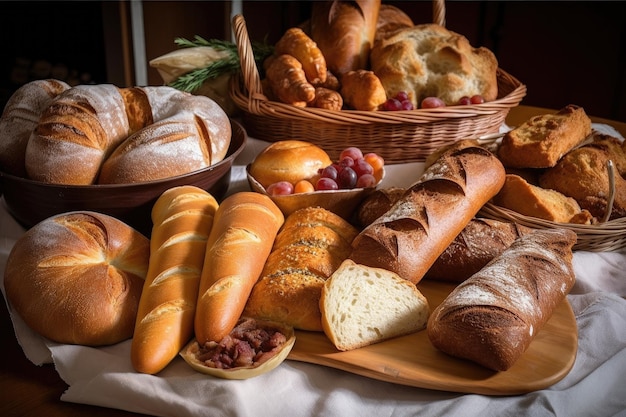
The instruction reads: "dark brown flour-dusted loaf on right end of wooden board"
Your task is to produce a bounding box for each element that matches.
[428,229,576,371]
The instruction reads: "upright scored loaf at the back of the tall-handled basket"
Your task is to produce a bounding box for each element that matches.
[311,0,381,75]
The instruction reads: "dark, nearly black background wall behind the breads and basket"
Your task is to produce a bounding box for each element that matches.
[0,1,626,121]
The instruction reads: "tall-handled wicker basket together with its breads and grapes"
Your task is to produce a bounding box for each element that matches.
[230,0,526,164]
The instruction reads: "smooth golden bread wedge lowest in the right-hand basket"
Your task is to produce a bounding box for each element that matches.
[493,174,593,224]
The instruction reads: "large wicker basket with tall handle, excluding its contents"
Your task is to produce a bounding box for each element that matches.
[230,0,526,164]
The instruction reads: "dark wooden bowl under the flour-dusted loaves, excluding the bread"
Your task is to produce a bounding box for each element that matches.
[0,121,247,237]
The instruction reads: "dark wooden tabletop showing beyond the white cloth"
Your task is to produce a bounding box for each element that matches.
[0,106,626,417]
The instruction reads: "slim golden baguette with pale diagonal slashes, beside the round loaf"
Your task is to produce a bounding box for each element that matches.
[131,186,218,374]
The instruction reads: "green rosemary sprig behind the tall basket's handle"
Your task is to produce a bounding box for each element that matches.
[169,35,274,92]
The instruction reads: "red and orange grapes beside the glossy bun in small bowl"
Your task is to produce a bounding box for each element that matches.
[266,146,385,196]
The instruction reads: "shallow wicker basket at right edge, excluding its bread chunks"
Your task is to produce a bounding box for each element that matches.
[479,203,626,252]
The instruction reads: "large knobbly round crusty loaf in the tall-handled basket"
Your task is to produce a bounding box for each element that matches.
[371,23,498,108]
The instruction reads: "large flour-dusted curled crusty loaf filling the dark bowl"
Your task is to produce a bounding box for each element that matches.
[25,84,231,185]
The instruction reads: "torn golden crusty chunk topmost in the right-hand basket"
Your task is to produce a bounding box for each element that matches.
[498,104,591,168]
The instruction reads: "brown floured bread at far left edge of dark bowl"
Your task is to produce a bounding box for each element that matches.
[0,79,70,177]
